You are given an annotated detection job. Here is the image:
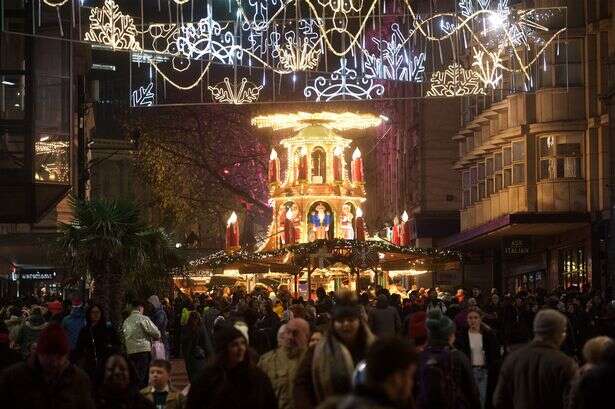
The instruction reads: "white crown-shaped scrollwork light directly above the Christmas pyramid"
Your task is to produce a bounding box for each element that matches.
[303,58,384,102]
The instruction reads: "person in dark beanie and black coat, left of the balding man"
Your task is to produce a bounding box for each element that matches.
[186,325,278,409]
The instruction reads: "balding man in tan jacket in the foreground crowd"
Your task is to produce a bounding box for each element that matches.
[258,318,310,409]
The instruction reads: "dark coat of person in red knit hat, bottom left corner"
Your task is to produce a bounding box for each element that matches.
[0,356,94,409]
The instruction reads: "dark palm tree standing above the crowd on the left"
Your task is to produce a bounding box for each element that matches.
[60,199,173,325]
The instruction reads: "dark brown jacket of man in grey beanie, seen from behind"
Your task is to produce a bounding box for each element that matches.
[493,340,576,409]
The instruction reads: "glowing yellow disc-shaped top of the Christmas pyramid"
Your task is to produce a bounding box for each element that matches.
[252,112,382,131]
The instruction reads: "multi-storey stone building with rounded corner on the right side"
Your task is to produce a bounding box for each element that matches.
[439,1,615,292]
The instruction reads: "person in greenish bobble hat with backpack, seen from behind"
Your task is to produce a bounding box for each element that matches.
[416,309,481,409]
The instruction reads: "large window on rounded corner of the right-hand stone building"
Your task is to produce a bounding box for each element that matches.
[538,135,582,180]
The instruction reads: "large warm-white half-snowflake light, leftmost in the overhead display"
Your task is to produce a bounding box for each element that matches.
[85,0,141,51]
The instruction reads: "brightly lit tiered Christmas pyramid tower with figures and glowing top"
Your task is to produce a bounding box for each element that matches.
[252,112,381,251]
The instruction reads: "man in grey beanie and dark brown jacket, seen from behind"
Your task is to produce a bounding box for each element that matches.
[493,308,577,409]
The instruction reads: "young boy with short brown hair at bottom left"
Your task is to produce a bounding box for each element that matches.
[141,359,186,409]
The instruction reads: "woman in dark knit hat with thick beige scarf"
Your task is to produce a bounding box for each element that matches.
[293,293,374,409]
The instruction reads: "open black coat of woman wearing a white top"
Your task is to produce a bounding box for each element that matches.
[455,326,502,409]
